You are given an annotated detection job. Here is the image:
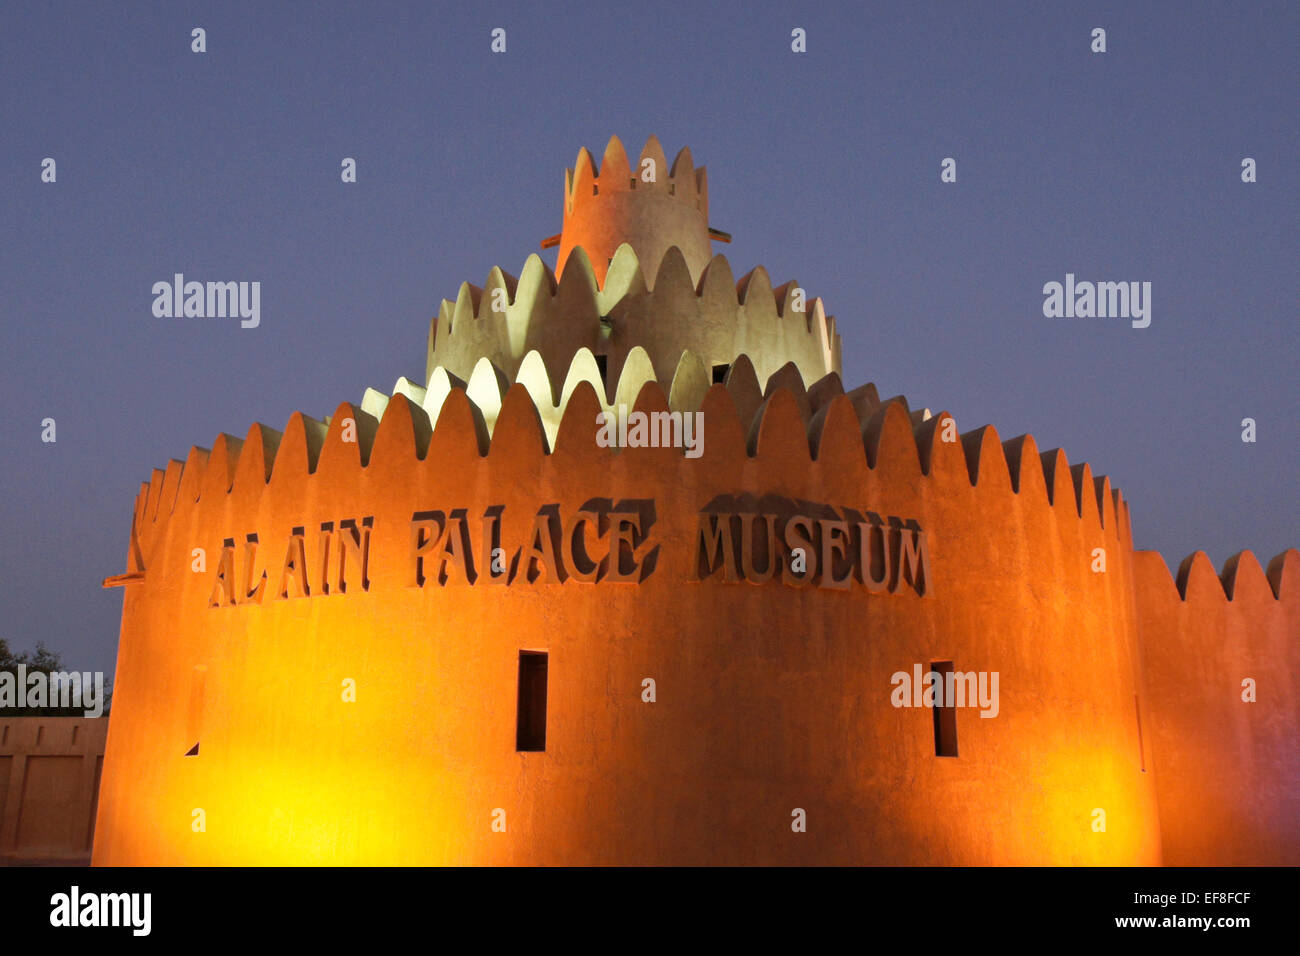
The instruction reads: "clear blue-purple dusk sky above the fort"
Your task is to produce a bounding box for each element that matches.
[0,0,1300,671]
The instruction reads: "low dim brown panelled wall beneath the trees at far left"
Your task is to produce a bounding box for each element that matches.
[0,717,108,862]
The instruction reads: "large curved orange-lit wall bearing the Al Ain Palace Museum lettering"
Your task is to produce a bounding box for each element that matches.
[95,384,1161,864]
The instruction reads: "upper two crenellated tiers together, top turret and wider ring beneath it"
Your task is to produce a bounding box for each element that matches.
[425,137,841,389]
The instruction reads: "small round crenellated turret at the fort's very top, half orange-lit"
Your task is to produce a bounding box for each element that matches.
[555,137,712,285]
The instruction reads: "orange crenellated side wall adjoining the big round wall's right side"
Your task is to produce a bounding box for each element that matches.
[1136,550,1300,866]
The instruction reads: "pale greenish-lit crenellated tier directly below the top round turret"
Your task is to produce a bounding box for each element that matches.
[426,245,841,398]
